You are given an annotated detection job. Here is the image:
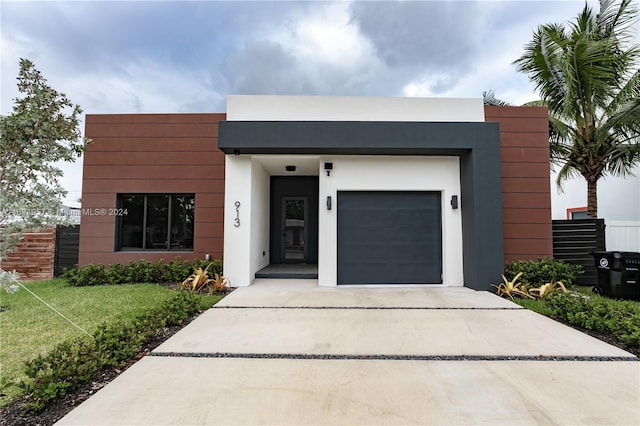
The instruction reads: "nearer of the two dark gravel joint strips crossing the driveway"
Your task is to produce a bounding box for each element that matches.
[148,352,640,362]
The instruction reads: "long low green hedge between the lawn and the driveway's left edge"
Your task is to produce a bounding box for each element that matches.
[18,292,208,410]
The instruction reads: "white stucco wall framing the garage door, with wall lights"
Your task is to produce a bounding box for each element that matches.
[318,156,464,286]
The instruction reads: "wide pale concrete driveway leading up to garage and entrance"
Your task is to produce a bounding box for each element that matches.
[59,280,640,425]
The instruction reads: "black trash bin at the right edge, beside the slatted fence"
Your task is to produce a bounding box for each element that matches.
[591,251,640,300]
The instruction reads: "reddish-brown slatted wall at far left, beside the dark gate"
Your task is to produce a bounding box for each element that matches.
[0,228,56,281]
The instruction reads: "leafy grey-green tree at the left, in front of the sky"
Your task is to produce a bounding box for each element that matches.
[0,59,84,260]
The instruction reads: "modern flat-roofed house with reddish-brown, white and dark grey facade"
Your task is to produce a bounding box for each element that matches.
[79,96,552,290]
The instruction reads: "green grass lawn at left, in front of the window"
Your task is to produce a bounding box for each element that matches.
[0,279,206,406]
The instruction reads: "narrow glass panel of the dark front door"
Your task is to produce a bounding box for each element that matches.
[280,197,308,263]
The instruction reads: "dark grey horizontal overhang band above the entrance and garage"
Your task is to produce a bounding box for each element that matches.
[218,121,500,155]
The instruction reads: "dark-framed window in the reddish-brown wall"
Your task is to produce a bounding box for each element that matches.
[116,194,195,250]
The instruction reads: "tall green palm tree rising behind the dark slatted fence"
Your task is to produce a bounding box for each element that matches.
[514,0,640,218]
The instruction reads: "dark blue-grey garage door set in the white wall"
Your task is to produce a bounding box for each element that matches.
[337,191,442,284]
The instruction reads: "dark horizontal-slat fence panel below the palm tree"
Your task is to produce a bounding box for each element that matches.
[553,219,606,285]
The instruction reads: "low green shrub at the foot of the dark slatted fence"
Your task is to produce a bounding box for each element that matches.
[504,259,584,287]
